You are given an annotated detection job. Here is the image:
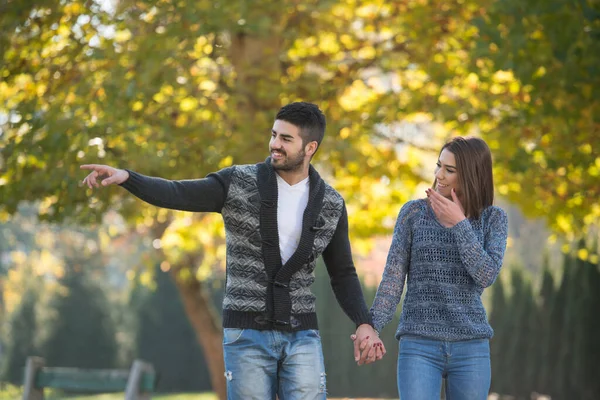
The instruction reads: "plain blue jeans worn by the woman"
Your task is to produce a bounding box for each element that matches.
[398,336,491,400]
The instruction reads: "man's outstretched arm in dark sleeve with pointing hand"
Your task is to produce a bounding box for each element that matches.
[81,164,233,212]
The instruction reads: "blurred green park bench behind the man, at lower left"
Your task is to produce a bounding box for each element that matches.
[22,357,156,400]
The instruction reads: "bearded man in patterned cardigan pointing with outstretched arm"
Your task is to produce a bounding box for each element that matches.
[81,102,381,400]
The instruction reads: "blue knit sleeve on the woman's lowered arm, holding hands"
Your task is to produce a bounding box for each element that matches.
[371,200,421,332]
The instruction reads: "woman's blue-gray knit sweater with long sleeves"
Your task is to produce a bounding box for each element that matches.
[371,199,508,341]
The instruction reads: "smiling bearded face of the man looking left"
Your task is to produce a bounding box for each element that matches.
[269,119,306,171]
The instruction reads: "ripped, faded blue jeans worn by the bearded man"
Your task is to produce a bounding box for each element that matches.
[223,328,326,400]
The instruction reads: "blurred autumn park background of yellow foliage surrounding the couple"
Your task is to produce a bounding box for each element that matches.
[0,0,600,399]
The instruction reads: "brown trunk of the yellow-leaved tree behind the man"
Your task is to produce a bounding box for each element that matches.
[147,27,282,400]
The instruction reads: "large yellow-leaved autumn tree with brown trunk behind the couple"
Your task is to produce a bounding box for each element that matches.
[0,0,600,398]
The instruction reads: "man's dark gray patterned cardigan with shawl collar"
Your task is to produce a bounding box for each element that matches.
[122,158,371,331]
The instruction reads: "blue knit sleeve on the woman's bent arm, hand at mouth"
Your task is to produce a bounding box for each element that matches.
[450,207,508,288]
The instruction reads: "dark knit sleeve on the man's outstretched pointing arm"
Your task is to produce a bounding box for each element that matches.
[121,167,235,212]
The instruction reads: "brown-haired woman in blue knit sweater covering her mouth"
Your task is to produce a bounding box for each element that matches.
[371,137,508,400]
